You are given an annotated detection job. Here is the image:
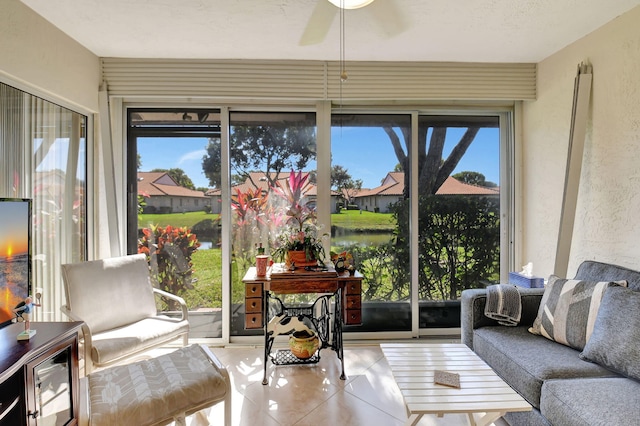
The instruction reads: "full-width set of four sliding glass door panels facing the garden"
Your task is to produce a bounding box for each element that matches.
[128,107,510,337]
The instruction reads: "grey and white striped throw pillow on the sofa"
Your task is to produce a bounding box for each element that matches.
[529,275,627,350]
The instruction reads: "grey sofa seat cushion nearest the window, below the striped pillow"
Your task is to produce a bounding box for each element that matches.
[473,326,619,408]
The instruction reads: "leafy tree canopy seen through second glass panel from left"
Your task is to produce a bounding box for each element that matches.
[202,122,316,187]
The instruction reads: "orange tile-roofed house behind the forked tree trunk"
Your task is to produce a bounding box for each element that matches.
[353,172,500,213]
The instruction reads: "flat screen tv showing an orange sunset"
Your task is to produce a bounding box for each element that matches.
[0,198,31,327]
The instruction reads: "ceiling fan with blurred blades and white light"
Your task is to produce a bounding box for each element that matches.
[300,0,406,46]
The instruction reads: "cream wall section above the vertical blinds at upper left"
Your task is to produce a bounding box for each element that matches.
[0,0,100,113]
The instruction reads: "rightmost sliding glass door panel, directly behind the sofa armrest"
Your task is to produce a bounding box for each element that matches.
[418,115,501,328]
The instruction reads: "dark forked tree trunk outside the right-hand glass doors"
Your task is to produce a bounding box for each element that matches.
[384,126,480,198]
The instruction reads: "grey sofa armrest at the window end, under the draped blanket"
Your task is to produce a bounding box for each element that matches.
[460,288,544,349]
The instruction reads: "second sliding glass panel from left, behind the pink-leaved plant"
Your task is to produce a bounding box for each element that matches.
[229,111,317,335]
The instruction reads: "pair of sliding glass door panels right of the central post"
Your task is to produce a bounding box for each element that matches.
[331,113,501,332]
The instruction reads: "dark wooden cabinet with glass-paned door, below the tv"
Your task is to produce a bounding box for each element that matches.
[0,322,82,426]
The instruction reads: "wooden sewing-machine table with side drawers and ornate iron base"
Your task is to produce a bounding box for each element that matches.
[242,267,362,385]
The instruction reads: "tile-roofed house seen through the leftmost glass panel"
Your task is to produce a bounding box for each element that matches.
[138,172,211,213]
